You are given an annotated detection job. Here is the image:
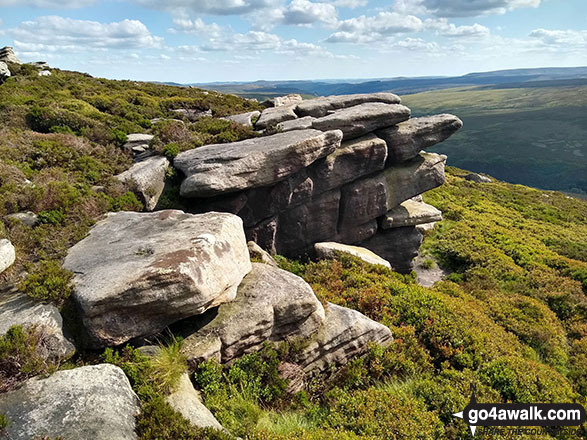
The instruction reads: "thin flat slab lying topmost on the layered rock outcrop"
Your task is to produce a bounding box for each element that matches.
[295,93,401,118]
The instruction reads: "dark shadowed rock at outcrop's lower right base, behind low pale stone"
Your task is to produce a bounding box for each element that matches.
[359,226,422,273]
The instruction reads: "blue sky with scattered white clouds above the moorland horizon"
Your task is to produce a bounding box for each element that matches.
[0,0,587,83]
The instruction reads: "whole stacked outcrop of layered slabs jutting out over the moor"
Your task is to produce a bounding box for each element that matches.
[174,93,462,272]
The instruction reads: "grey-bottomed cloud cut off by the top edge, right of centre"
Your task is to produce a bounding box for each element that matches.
[394,0,541,17]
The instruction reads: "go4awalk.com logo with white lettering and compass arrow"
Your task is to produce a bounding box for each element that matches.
[453,392,585,435]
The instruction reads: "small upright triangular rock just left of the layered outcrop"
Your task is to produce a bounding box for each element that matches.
[115,156,169,211]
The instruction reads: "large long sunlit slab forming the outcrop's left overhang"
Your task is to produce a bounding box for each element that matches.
[174,130,342,198]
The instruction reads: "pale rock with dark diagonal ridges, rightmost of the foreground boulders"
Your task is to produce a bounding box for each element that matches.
[300,303,393,374]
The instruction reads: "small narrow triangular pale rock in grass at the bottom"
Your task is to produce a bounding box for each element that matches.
[165,373,226,431]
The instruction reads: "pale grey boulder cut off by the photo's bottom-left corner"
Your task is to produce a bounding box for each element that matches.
[0,364,140,440]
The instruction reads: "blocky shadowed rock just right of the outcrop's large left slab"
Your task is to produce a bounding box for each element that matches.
[309,134,387,193]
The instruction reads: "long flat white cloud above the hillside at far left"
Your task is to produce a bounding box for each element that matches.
[10,16,163,52]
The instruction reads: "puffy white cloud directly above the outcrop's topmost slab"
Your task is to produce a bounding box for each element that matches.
[326,12,424,43]
